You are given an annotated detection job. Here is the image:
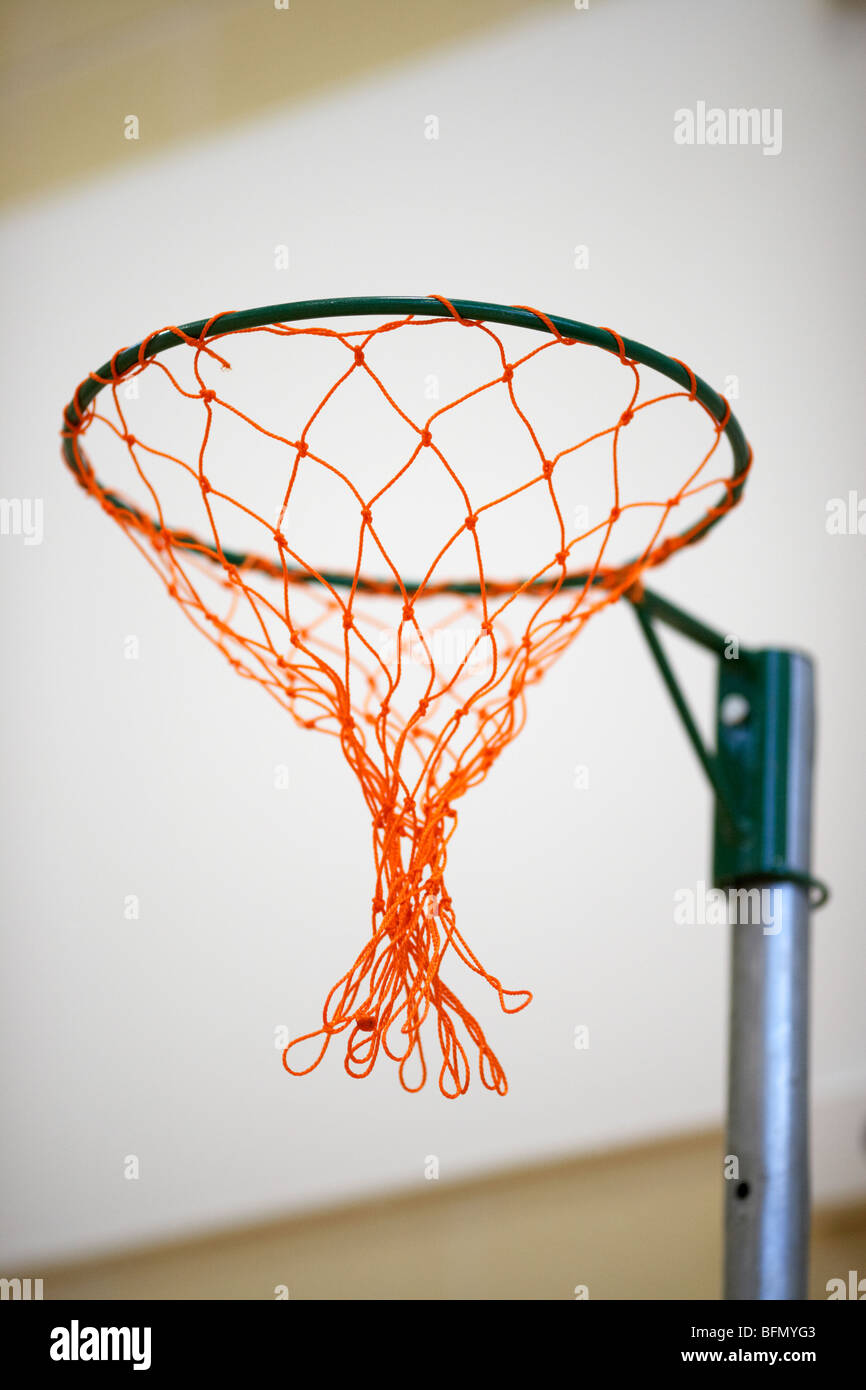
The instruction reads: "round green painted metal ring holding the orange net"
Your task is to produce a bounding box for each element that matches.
[63,295,751,594]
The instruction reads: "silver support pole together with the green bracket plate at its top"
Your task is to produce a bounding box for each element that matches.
[716,652,815,1300]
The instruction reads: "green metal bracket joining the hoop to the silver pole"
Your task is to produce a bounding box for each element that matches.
[628,589,828,908]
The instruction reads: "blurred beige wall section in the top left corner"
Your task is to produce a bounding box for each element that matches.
[0,0,558,199]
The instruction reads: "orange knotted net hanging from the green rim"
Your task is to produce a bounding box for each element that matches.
[64,300,735,1097]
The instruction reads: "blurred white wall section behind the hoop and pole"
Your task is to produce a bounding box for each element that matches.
[0,0,866,1259]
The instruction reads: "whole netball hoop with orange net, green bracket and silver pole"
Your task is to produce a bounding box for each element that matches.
[63,296,828,1298]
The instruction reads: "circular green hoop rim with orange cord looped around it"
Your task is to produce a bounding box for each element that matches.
[61,295,752,595]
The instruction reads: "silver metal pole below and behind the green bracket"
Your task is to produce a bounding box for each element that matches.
[721,653,815,1300]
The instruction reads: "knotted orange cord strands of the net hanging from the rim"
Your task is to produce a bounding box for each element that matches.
[65,304,750,1097]
